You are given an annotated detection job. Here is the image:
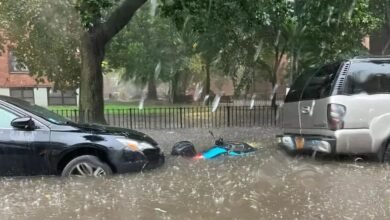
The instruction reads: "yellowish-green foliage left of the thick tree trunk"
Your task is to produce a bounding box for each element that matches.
[0,0,81,89]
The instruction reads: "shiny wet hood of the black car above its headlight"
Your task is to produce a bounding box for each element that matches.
[64,123,158,146]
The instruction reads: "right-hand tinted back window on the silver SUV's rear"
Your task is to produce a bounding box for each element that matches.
[301,63,340,100]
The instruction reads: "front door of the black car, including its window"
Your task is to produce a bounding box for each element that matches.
[0,105,33,176]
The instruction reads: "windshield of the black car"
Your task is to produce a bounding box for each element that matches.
[9,99,71,125]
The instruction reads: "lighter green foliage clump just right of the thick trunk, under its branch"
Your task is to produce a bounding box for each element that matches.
[107,5,181,85]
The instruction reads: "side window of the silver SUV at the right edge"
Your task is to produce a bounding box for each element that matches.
[346,60,390,95]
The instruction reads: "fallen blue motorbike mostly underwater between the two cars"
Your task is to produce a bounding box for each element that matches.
[171,131,256,160]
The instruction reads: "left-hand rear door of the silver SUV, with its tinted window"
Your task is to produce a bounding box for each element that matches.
[283,69,316,133]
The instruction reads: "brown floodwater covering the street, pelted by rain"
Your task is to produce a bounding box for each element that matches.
[0,128,390,220]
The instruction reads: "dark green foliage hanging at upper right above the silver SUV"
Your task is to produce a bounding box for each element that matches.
[162,0,384,91]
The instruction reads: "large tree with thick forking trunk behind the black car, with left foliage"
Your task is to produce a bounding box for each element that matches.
[0,0,146,123]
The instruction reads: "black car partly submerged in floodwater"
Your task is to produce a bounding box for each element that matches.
[0,96,164,176]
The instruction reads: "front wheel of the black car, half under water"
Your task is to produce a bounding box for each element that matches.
[61,155,112,177]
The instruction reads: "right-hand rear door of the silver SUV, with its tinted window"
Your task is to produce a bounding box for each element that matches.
[299,63,340,131]
